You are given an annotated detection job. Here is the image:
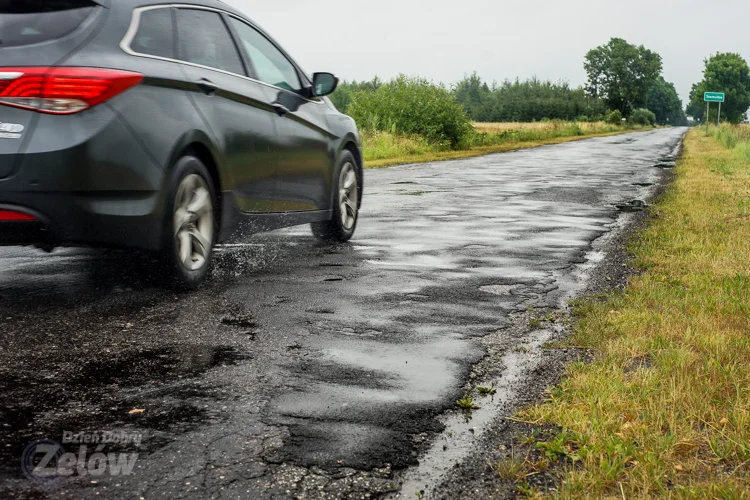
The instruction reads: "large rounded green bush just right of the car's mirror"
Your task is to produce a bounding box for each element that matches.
[347,76,474,148]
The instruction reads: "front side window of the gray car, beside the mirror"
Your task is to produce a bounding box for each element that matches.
[230,18,302,93]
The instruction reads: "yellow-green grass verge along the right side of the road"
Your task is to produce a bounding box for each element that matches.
[516,129,750,498]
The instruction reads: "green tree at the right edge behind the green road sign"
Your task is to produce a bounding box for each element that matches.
[688,53,750,123]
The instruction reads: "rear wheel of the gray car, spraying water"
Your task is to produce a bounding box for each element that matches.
[162,155,218,290]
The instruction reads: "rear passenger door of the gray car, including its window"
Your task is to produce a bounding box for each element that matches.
[175,6,278,212]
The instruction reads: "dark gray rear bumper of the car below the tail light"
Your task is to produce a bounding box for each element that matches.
[0,100,165,250]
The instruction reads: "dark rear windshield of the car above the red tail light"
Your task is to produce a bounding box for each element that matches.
[0,0,97,49]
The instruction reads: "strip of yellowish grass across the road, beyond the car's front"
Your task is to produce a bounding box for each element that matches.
[362,122,643,168]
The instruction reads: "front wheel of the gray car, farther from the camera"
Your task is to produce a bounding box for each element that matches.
[312,151,360,242]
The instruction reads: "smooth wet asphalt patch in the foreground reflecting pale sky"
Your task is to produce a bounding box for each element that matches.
[270,336,483,468]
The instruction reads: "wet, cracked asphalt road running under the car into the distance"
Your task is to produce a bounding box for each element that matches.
[0,129,684,498]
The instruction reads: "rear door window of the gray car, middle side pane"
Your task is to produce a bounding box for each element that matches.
[177,9,245,75]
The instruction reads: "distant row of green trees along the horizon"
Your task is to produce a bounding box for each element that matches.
[332,38,750,129]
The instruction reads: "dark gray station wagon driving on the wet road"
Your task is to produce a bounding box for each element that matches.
[0,0,362,287]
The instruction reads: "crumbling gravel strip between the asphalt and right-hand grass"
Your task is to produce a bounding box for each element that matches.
[396,131,687,500]
